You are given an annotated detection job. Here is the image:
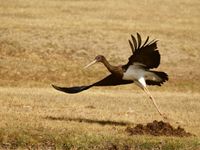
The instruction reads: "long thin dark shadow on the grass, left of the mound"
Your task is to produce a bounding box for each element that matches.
[44,116,133,126]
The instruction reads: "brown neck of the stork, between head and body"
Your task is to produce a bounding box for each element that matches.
[102,59,123,77]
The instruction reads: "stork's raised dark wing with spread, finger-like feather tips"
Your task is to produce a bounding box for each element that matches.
[125,33,160,69]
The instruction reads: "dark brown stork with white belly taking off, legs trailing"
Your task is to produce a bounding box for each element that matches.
[52,33,168,116]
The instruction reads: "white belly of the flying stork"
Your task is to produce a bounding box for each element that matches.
[123,66,145,81]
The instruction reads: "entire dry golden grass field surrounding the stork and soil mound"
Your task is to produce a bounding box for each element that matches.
[0,0,200,150]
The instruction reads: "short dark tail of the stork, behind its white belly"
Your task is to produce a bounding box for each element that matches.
[146,71,169,86]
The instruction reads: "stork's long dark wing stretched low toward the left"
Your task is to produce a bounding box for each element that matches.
[52,74,133,94]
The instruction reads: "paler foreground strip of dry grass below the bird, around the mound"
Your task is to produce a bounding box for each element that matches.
[0,87,200,150]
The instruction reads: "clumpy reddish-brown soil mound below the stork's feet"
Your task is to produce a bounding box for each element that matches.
[126,120,192,137]
